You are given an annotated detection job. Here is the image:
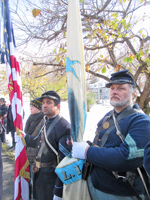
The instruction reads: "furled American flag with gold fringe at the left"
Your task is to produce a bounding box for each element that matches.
[2,0,30,200]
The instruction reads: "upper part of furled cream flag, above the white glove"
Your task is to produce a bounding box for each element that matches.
[66,0,86,142]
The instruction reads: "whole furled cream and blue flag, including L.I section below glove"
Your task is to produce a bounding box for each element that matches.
[55,0,90,200]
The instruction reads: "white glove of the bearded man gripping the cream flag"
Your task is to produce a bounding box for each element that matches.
[72,142,90,159]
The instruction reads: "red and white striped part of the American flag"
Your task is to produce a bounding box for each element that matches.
[6,42,30,200]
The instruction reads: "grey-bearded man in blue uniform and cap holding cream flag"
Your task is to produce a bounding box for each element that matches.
[72,70,150,200]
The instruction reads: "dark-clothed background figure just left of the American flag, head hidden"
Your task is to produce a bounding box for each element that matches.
[7,105,15,151]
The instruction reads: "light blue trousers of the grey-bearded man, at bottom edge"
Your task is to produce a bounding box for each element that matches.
[88,176,148,200]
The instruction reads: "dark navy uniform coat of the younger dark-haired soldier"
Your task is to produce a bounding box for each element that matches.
[25,117,72,200]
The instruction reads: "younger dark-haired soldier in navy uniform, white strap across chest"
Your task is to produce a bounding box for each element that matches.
[15,90,72,200]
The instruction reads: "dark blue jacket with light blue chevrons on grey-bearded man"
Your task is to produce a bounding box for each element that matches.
[87,104,150,196]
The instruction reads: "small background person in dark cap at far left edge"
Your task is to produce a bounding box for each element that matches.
[0,98,8,142]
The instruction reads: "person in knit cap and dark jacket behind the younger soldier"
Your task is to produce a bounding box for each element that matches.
[24,98,44,199]
